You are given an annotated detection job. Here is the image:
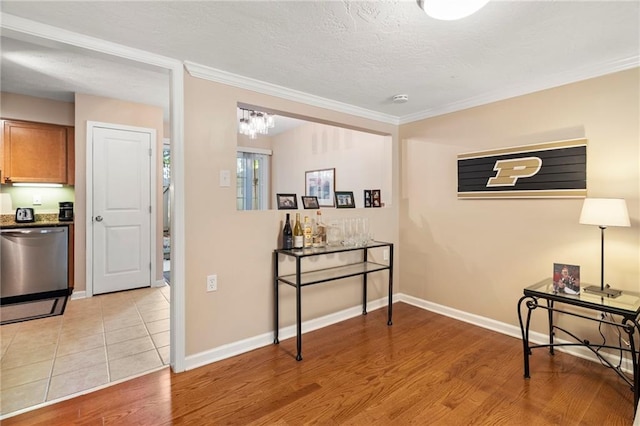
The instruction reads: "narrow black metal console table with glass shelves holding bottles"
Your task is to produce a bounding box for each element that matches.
[273,241,393,361]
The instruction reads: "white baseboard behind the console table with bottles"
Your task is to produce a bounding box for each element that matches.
[186,297,388,370]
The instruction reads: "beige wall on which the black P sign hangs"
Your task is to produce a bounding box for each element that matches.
[400,69,640,340]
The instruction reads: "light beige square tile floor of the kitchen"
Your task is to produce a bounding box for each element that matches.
[0,285,169,416]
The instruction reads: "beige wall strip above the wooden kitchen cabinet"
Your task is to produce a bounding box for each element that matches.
[0,92,75,126]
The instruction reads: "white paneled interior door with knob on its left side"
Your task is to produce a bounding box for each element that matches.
[92,127,154,294]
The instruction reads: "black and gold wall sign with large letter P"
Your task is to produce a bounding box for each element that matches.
[458,139,587,198]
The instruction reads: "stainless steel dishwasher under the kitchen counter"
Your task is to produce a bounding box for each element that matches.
[0,226,69,302]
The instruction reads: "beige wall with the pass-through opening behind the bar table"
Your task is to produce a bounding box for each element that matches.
[184,75,398,356]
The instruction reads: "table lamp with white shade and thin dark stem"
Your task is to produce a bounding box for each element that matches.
[580,198,631,297]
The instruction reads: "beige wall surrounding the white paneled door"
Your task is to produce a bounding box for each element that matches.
[74,94,164,291]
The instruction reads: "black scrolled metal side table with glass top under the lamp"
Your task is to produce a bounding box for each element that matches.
[518,278,640,410]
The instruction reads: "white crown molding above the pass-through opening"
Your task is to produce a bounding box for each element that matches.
[184,61,400,125]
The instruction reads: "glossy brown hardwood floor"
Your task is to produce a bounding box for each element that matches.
[3,303,634,426]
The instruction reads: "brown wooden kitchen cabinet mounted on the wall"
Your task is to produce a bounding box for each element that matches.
[0,120,75,185]
